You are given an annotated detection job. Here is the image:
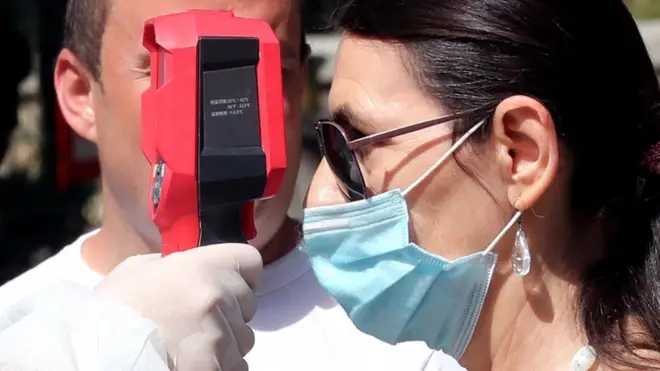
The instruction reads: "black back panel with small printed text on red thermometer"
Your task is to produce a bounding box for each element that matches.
[197,37,267,243]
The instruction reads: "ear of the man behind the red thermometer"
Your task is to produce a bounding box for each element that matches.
[54,49,96,143]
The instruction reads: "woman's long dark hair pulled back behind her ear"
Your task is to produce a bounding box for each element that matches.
[338,0,660,369]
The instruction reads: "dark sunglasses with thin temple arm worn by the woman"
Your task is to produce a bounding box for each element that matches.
[316,109,483,201]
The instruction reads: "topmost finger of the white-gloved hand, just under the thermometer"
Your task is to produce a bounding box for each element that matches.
[186,243,263,290]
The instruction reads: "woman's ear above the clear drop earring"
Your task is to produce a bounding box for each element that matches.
[493,96,559,210]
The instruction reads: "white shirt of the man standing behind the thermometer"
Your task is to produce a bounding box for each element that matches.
[0,232,463,371]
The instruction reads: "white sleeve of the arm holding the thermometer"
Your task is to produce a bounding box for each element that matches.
[0,283,169,371]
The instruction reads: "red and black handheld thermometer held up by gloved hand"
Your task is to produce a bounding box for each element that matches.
[141,10,286,255]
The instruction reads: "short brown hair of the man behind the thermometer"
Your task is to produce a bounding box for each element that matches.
[63,0,309,81]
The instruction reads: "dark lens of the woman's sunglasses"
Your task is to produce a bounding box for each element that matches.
[318,123,365,200]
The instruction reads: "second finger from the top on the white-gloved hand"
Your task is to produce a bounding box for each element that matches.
[216,271,258,323]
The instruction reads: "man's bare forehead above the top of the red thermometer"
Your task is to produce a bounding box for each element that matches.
[107,0,300,52]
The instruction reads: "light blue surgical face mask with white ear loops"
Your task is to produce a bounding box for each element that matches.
[302,122,521,359]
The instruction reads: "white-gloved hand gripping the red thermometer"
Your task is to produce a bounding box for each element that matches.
[96,244,263,371]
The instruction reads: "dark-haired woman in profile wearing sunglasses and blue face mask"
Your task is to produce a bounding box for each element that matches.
[304,0,660,371]
